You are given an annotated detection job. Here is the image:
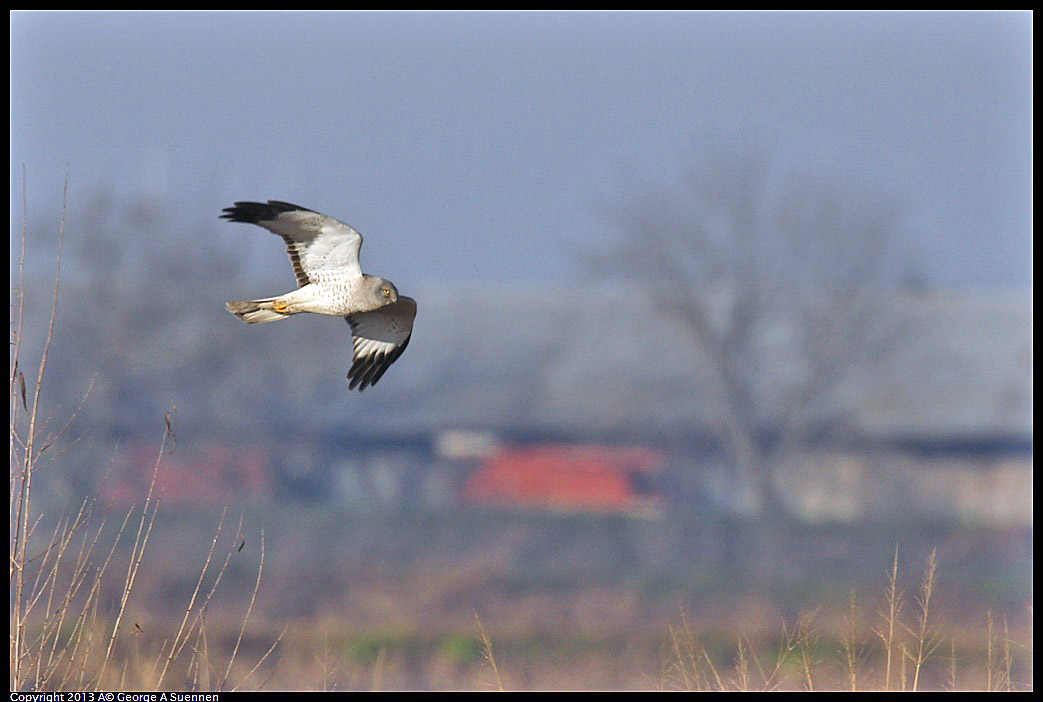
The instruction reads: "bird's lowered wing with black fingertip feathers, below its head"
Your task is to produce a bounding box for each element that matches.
[344,297,416,392]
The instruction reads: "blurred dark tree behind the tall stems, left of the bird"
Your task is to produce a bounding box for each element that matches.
[21,188,256,438]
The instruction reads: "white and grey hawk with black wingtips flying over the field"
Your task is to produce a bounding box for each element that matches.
[221,200,416,392]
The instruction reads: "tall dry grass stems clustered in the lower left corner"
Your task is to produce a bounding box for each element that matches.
[9,179,280,691]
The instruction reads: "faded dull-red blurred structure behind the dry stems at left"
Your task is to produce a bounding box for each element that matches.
[101,443,270,508]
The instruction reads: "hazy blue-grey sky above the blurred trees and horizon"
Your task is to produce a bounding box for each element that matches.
[10,11,1033,287]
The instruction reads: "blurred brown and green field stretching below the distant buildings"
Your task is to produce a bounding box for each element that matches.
[10,492,1032,691]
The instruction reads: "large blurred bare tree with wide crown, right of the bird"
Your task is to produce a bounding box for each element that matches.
[598,153,907,516]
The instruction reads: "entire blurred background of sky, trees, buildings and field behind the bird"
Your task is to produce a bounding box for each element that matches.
[10,11,1033,689]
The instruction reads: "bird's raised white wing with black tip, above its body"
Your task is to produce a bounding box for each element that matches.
[221,200,362,288]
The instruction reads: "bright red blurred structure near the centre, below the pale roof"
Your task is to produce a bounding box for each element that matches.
[463,445,665,512]
